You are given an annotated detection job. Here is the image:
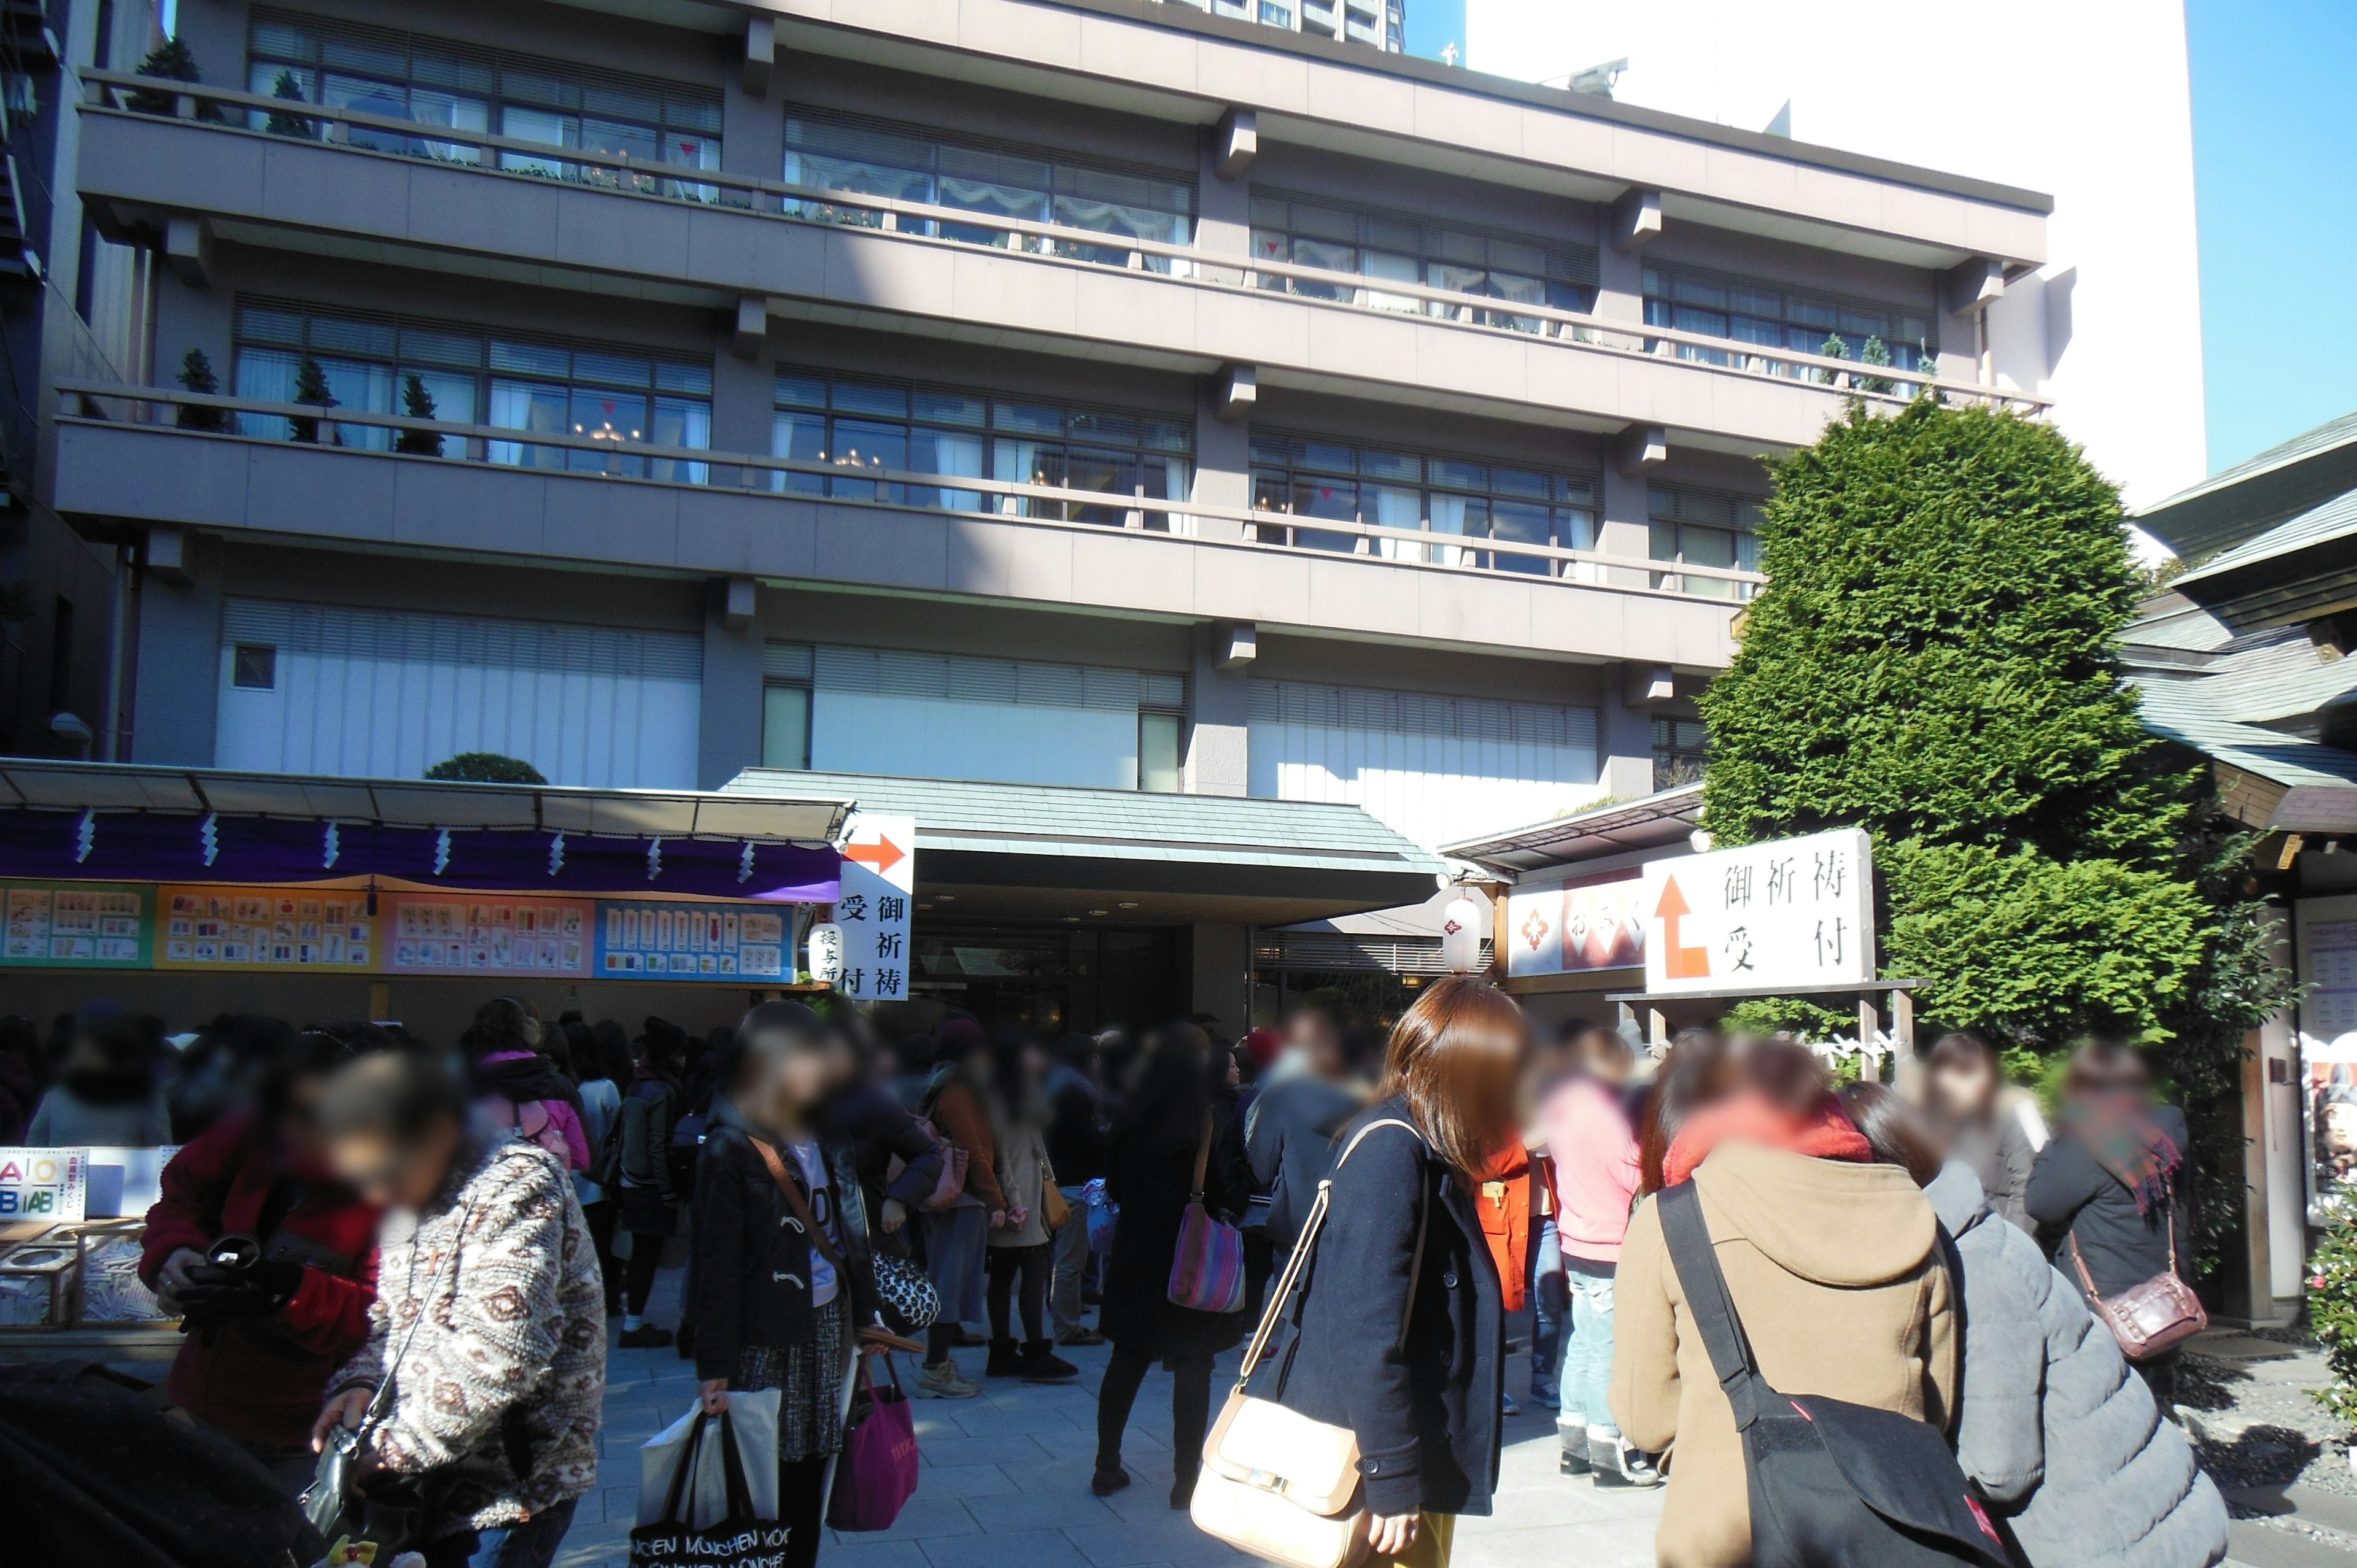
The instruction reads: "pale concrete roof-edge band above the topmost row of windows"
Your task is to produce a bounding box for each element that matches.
[712,0,2053,269]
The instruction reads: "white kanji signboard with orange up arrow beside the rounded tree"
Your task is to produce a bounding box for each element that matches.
[1643,828,1874,993]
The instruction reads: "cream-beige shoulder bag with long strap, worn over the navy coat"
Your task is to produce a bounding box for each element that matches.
[1188,1118,1428,1568]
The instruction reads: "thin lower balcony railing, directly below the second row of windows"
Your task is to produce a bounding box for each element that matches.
[56,382,1765,601]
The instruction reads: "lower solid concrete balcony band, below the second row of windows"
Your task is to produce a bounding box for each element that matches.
[54,417,1735,670]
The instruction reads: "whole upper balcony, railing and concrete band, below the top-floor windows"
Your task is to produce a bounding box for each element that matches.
[78,71,2043,450]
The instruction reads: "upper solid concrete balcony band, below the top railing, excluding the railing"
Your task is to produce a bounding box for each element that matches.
[78,106,1914,455]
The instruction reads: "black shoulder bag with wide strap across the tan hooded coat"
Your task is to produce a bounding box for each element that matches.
[1657,1181,2013,1568]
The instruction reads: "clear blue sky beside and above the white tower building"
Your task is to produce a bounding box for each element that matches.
[1407,0,2357,469]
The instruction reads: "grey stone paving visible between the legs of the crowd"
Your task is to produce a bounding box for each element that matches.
[556,1269,1662,1568]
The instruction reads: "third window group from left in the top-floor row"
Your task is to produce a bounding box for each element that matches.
[1252,191,1596,333]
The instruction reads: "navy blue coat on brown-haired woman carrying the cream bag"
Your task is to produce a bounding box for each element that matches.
[1252,1099,1506,1514]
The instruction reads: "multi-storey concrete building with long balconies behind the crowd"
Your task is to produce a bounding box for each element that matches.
[18,0,2048,1023]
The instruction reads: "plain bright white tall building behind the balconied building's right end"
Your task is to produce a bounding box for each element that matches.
[1466,0,2208,523]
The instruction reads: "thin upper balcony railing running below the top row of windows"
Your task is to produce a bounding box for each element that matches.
[80,71,2051,412]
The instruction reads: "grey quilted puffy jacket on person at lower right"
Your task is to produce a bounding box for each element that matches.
[1923,1160,2225,1568]
